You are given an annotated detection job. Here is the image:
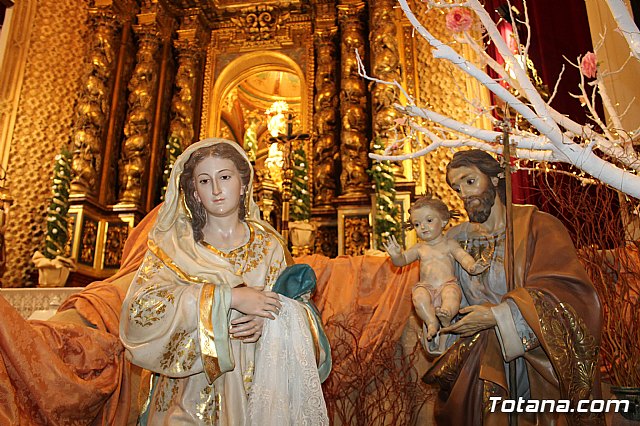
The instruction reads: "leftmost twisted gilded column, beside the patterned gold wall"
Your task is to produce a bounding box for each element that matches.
[71,0,135,197]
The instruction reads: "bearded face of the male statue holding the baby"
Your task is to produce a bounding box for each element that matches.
[447,166,497,223]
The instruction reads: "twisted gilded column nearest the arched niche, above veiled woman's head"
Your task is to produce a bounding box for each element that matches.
[169,16,209,149]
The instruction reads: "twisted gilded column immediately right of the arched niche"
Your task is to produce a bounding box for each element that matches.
[313,2,339,209]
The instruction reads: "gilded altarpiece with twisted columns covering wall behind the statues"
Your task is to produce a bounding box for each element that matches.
[0,0,492,287]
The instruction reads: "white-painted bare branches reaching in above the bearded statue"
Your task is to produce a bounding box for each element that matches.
[361,0,640,198]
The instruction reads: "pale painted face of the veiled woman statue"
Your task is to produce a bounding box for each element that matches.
[193,156,244,223]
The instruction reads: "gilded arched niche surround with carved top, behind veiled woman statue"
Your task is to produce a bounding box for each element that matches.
[200,4,315,236]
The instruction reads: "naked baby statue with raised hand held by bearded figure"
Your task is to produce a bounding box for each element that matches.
[384,195,489,341]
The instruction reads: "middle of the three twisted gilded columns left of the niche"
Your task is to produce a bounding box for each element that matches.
[118,0,172,206]
